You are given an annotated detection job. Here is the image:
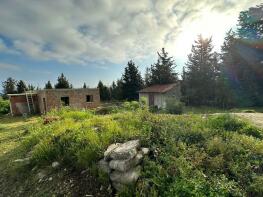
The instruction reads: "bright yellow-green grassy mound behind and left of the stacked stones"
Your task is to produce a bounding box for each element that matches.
[25,102,153,168]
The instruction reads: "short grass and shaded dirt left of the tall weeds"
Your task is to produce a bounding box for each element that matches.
[0,116,108,197]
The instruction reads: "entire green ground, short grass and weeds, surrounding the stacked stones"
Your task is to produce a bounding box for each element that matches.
[0,103,263,196]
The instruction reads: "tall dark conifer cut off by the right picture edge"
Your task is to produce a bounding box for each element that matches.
[235,4,263,106]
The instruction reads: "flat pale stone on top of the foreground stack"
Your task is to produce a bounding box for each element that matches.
[110,140,140,160]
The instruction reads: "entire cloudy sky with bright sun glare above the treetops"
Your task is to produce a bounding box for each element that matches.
[0,0,262,88]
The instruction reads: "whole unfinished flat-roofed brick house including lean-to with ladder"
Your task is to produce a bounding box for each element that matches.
[8,88,100,115]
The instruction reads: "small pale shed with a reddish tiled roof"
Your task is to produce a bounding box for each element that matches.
[139,83,181,108]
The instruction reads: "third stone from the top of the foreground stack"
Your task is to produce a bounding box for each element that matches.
[110,166,141,185]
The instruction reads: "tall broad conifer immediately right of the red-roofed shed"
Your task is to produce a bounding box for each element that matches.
[182,35,218,105]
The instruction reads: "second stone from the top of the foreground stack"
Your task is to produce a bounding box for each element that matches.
[109,153,143,172]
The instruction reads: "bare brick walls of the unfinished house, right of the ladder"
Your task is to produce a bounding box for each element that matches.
[38,88,100,113]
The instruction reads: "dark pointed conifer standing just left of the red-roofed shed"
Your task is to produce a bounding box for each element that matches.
[122,60,143,100]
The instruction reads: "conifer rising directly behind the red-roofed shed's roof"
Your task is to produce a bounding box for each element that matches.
[148,48,178,85]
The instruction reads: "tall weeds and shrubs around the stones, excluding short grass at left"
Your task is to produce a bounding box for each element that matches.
[17,105,263,196]
